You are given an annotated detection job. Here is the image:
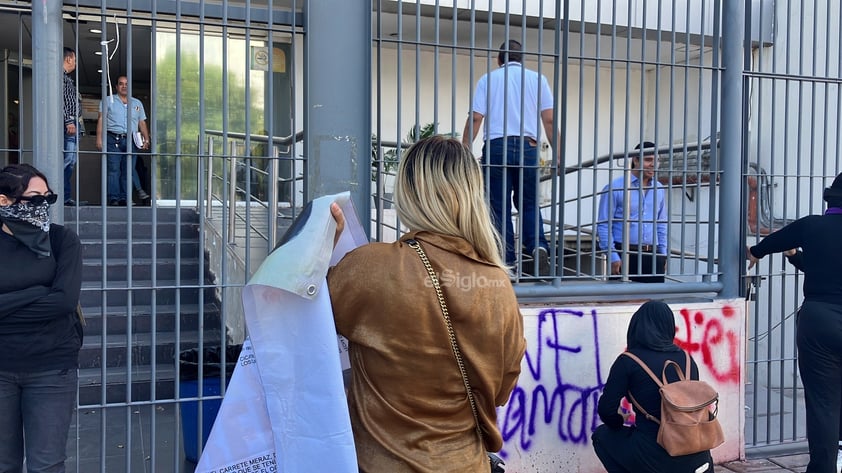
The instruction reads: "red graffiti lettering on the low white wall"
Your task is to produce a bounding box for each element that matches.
[675,305,740,383]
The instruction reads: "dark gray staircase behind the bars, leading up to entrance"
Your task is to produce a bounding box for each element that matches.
[65,207,224,406]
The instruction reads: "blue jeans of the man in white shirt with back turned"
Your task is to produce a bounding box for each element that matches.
[482,137,549,264]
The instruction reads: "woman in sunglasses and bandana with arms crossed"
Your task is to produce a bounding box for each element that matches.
[0,164,82,473]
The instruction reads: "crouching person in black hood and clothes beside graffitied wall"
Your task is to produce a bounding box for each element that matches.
[591,301,713,473]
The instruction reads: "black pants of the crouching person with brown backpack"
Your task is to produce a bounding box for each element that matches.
[591,424,713,473]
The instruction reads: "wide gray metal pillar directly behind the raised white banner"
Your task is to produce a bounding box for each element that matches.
[304,0,371,234]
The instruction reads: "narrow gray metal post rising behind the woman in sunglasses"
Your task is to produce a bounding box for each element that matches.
[32,2,64,223]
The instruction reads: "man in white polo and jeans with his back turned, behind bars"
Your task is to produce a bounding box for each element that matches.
[462,40,561,276]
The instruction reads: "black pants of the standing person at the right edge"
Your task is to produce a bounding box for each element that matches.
[795,300,842,473]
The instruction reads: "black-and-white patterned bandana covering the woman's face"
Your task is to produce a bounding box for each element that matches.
[0,201,50,257]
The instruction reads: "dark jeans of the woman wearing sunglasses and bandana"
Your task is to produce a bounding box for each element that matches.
[0,368,77,473]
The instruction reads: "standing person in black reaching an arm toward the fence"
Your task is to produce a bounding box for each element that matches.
[747,173,842,473]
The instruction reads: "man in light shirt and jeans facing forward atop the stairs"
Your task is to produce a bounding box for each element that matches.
[96,76,149,205]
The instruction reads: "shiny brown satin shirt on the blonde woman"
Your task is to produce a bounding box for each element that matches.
[328,232,526,472]
